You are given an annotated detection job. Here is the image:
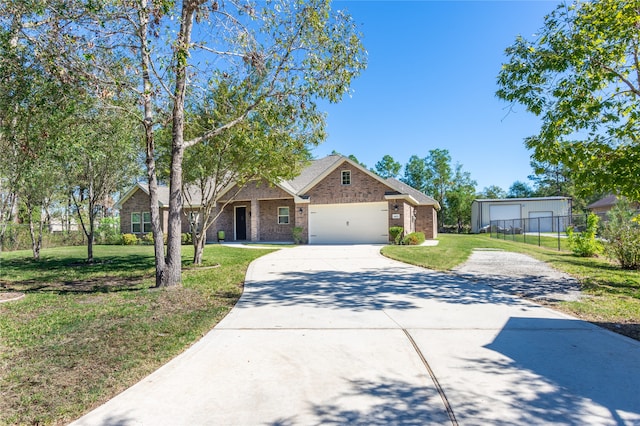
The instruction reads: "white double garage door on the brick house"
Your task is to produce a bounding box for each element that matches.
[309,202,389,244]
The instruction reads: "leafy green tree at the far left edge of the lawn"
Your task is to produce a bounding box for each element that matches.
[0,12,71,260]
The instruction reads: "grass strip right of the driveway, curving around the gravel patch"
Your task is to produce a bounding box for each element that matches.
[382,234,640,340]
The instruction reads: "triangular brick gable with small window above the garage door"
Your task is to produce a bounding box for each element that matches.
[306,163,389,204]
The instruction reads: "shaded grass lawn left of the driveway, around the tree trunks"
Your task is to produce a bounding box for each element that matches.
[0,245,271,424]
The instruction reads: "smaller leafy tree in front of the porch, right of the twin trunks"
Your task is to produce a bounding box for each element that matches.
[183,83,324,264]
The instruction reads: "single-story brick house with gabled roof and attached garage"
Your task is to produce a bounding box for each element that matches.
[117,155,440,244]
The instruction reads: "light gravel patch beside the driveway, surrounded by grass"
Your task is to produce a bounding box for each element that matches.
[453,249,580,302]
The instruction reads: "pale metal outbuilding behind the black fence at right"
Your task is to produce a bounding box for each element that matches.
[471,197,571,233]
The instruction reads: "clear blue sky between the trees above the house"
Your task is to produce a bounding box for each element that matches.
[314,0,558,191]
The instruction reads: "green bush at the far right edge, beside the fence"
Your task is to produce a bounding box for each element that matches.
[602,198,640,269]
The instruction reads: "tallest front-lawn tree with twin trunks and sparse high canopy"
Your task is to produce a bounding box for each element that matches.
[10,0,366,286]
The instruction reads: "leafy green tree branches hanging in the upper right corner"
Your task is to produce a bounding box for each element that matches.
[497,0,640,200]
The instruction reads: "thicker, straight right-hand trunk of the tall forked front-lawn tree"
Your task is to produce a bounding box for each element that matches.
[160,1,199,287]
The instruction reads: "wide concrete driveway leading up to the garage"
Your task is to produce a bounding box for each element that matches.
[75,246,640,425]
